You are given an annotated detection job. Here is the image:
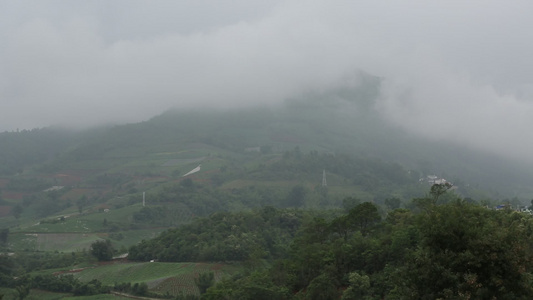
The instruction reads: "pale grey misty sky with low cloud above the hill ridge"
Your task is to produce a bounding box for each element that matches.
[0,0,533,161]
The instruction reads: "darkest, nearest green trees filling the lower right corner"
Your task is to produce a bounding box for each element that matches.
[203,200,533,299]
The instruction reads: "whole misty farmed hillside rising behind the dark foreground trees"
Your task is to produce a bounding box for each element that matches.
[0,76,533,295]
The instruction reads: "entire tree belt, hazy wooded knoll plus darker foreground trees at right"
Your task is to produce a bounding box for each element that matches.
[130,185,533,299]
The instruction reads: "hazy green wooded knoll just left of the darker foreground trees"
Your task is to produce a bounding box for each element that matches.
[128,207,304,262]
